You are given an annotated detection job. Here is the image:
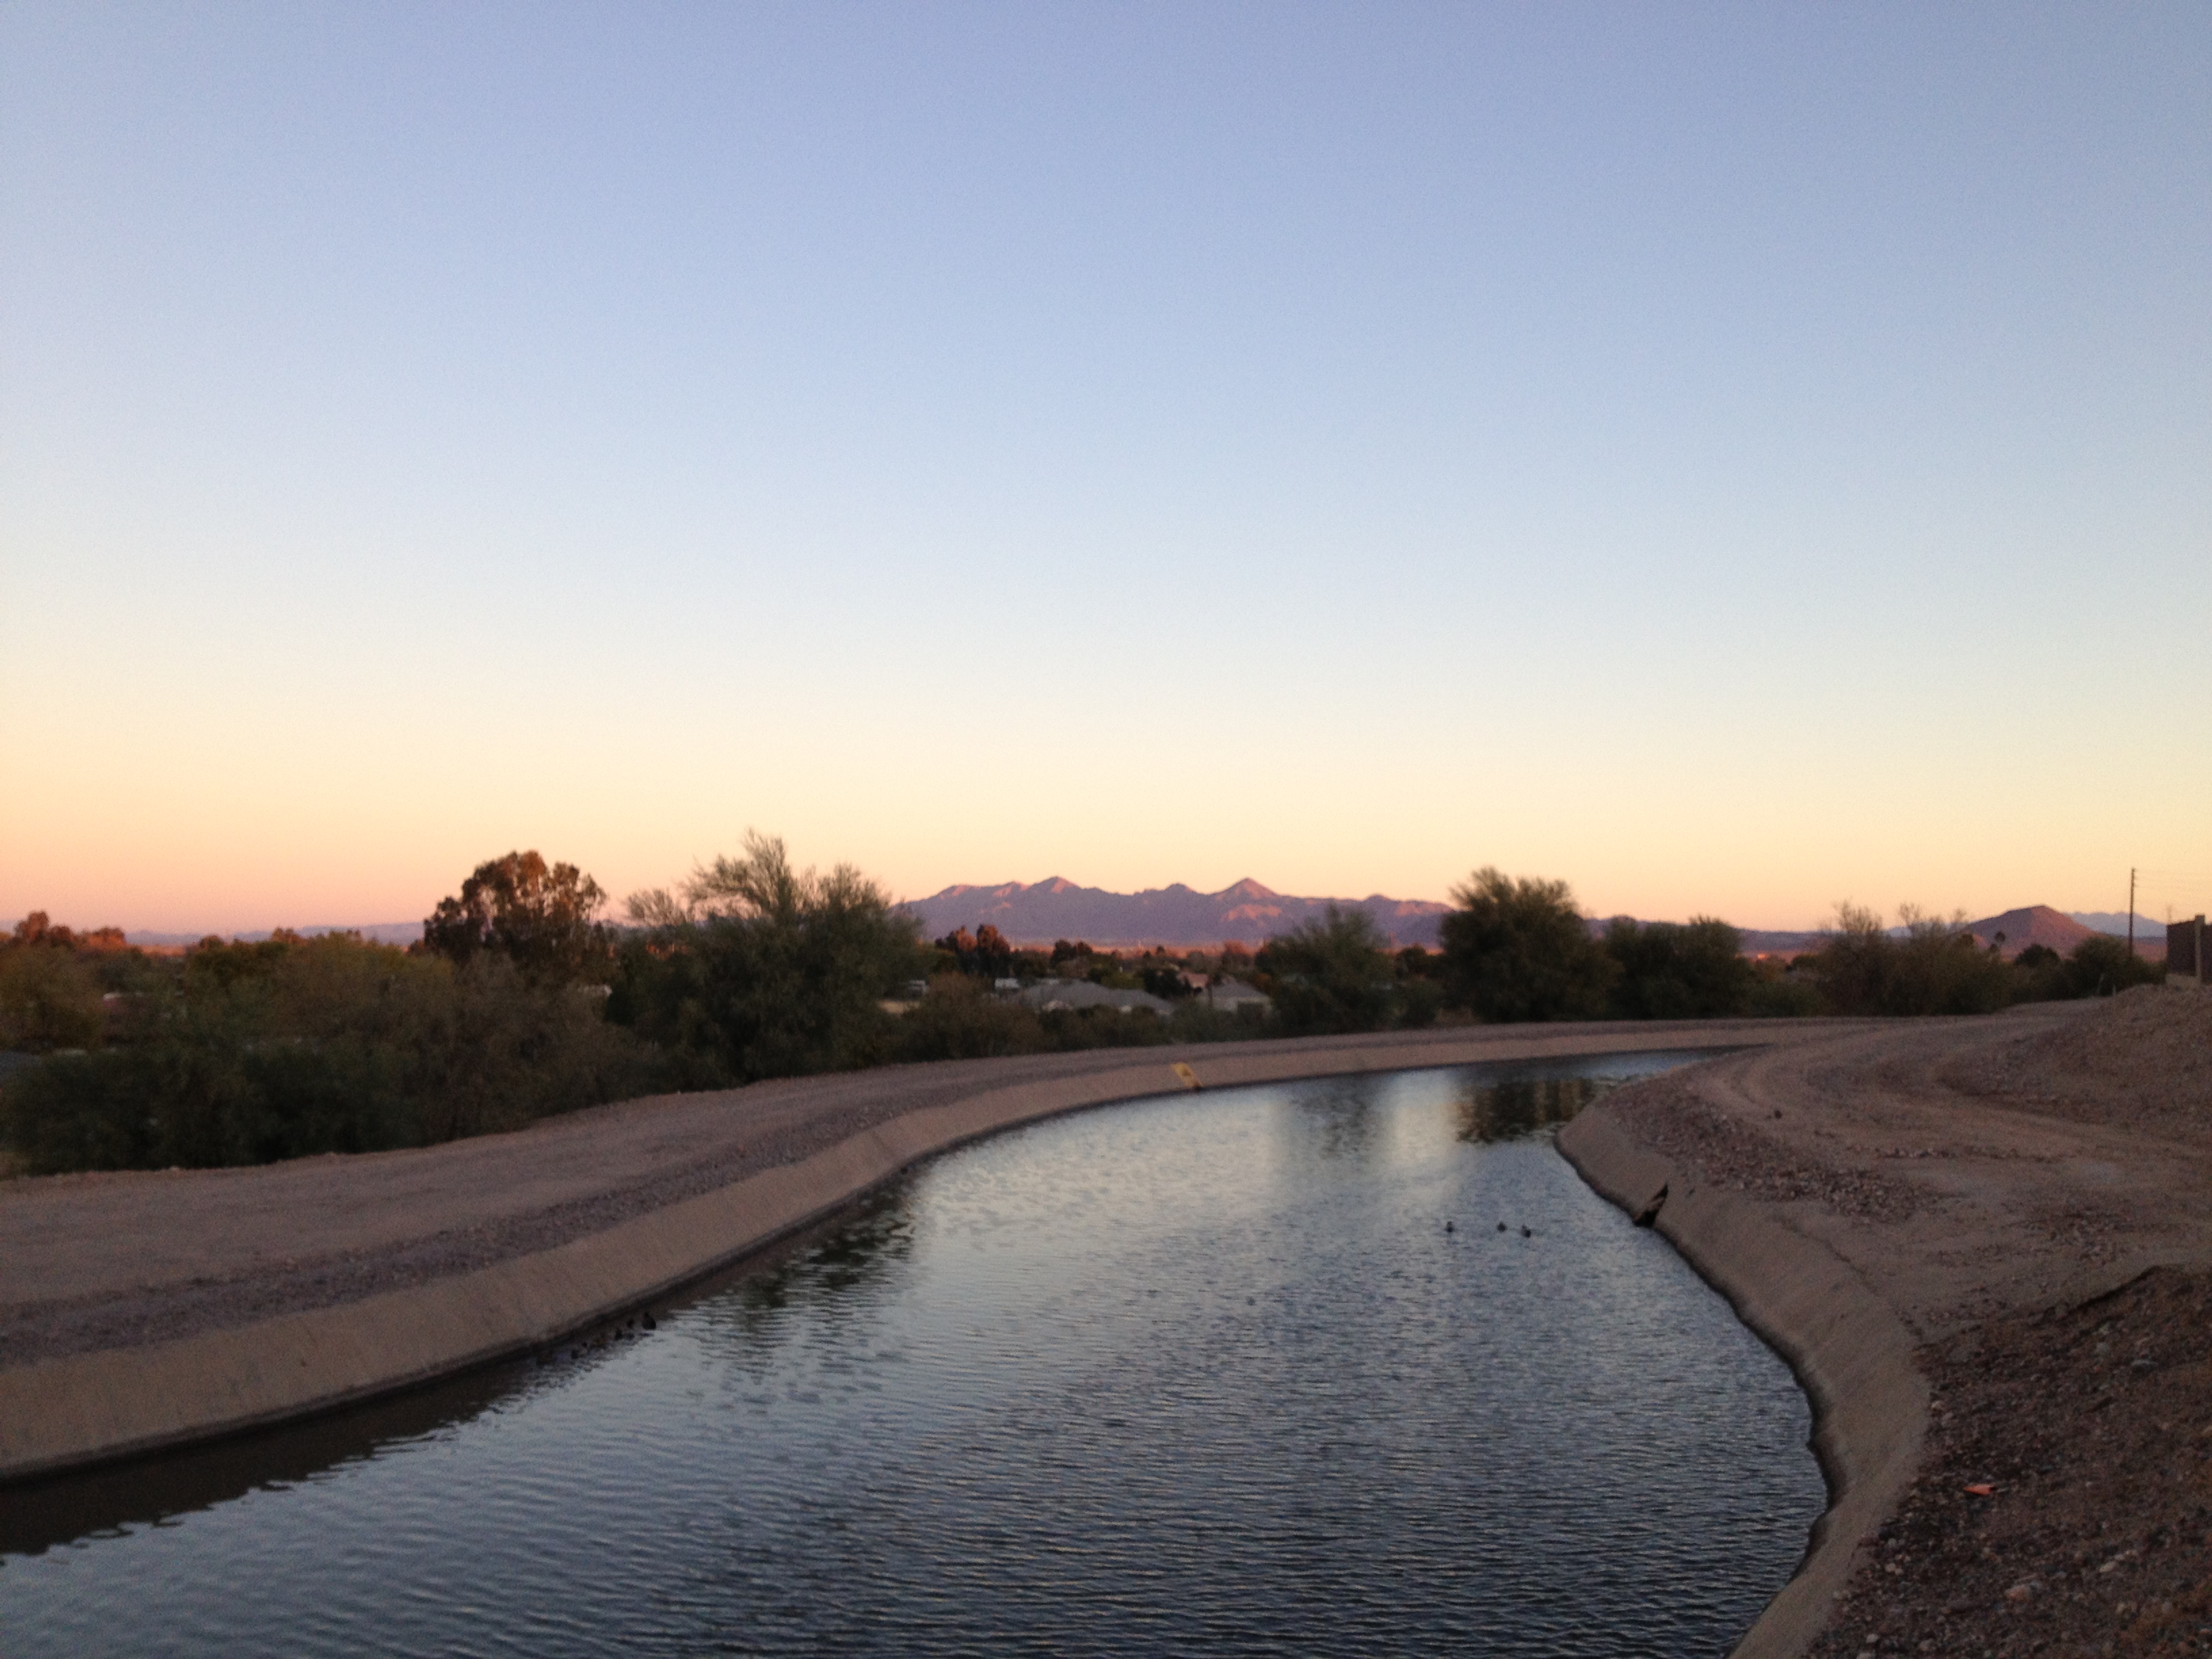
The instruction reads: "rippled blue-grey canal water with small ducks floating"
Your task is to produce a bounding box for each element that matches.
[0,1055,1825,1659]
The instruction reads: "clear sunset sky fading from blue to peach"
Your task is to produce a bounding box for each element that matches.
[0,0,2212,931]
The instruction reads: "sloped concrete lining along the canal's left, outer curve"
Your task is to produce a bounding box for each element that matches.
[0,1022,1778,1480]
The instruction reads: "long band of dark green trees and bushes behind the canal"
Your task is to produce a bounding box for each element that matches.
[0,836,2159,1172]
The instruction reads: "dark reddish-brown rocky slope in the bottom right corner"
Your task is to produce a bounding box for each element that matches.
[1811,1267,2212,1659]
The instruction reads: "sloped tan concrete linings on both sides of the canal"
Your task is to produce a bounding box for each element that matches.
[0,1022,1927,1659]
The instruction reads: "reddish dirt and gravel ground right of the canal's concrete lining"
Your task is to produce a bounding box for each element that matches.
[1595,989,2212,1659]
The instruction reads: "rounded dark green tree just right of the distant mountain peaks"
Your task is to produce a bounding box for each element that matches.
[1440,865,1619,1020]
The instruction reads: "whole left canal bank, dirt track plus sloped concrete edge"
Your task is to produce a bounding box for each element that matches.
[0,1022,1834,1480]
